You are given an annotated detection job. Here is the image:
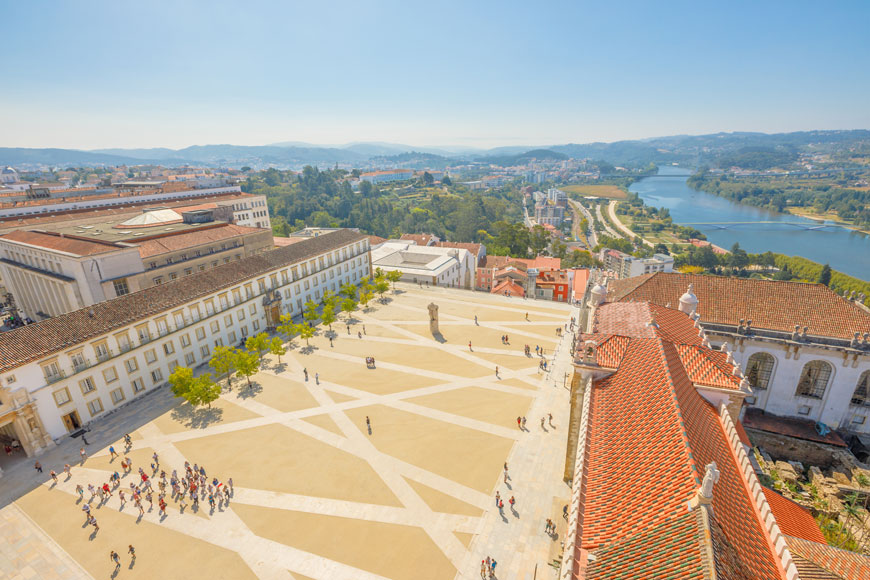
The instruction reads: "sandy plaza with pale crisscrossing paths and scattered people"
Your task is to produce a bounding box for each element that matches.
[0,284,576,580]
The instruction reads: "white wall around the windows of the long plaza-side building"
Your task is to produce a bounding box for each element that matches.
[7,240,371,439]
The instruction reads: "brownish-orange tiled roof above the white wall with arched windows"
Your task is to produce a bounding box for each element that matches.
[608,272,870,338]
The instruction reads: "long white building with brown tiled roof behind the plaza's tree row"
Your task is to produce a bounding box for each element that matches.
[0,230,371,466]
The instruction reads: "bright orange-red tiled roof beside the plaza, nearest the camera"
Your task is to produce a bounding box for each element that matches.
[575,304,784,580]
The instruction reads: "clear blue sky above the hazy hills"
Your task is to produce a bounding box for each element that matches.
[0,0,870,149]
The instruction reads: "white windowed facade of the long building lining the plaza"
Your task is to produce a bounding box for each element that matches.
[0,233,371,446]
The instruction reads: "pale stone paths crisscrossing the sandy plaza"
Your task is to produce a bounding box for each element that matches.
[23,287,576,580]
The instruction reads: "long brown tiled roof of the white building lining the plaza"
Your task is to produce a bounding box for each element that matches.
[0,229,365,372]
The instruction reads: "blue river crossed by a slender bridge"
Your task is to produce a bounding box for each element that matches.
[629,167,870,280]
